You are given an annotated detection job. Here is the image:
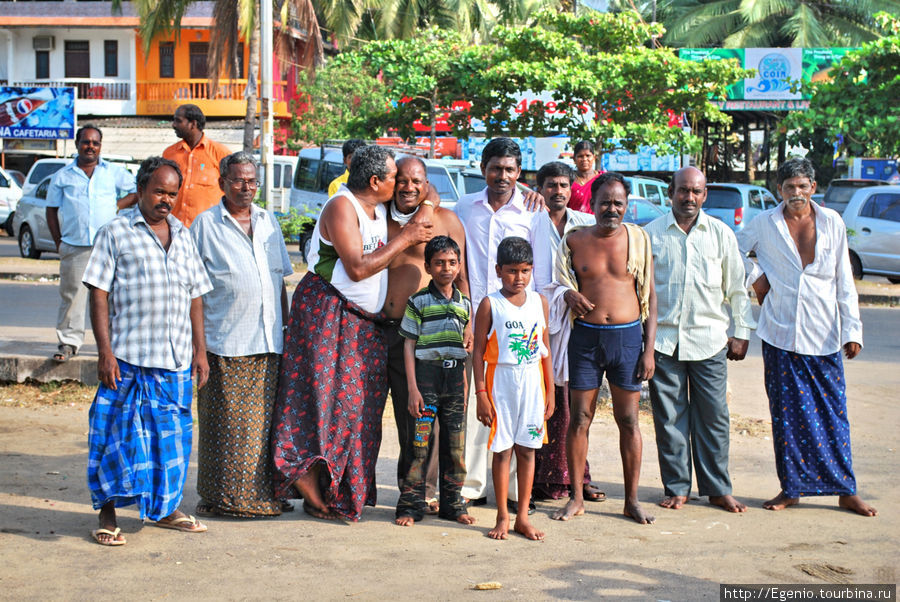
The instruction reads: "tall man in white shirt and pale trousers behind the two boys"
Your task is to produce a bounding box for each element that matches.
[456,138,553,505]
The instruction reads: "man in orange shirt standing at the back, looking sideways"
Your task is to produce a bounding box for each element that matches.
[163,104,231,227]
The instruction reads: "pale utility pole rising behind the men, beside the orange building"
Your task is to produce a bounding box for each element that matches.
[259,0,281,211]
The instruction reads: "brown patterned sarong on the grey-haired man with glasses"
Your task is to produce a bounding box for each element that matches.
[197,353,281,517]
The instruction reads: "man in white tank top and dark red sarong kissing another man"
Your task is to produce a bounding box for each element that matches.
[272,146,432,521]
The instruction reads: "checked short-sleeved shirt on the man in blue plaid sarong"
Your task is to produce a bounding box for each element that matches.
[82,207,212,370]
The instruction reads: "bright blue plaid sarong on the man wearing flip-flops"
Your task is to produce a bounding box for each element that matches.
[87,360,193,520]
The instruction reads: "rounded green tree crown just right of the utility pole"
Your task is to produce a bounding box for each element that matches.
[288,60,388,149]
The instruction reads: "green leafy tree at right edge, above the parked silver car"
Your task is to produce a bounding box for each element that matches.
[783,13,900,157]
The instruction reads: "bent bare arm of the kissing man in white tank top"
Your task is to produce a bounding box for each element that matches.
[320,196,433,282]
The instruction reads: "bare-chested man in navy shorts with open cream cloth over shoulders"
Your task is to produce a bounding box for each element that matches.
[553,172,656,524]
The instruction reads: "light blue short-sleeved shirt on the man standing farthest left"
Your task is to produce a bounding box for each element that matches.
[47,158,137,247]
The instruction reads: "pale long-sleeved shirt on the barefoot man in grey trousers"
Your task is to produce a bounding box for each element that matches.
[644,211,756,361]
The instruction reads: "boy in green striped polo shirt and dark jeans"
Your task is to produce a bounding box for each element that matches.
[394,236,475,527]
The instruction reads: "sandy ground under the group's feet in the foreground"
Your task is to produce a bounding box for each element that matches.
[0,350,900,600]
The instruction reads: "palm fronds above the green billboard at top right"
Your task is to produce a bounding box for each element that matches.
[652,0,900,48]
